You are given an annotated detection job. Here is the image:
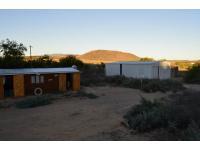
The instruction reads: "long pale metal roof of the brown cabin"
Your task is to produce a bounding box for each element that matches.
[0,67,79,75]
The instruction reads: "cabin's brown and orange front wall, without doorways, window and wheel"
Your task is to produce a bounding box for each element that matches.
[0,72,80,98]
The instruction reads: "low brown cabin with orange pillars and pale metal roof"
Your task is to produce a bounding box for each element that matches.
[0,68,80,98]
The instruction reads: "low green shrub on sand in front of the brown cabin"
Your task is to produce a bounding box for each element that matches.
[16,96,53,108]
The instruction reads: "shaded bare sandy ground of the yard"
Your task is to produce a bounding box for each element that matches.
[0,87,173,140]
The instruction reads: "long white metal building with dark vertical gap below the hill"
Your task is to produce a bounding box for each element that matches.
[105,61,171,79]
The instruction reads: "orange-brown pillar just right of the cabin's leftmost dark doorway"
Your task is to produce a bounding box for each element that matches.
[13,75,24,97]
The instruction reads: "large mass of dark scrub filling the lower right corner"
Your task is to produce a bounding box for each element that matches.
[124,91,200,140]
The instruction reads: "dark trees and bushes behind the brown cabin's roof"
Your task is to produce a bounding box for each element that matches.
[0,39,84,69]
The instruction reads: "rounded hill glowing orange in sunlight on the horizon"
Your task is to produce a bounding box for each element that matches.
[77,50,140,63]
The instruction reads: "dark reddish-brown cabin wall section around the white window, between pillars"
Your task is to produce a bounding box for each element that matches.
[24,74,59,95]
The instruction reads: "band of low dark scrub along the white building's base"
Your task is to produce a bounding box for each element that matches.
[81,74,184,93]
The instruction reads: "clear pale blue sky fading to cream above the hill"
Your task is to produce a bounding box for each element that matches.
[0,9,200,60]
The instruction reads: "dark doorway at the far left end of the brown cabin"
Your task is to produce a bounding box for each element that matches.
[4,76,13,97]
